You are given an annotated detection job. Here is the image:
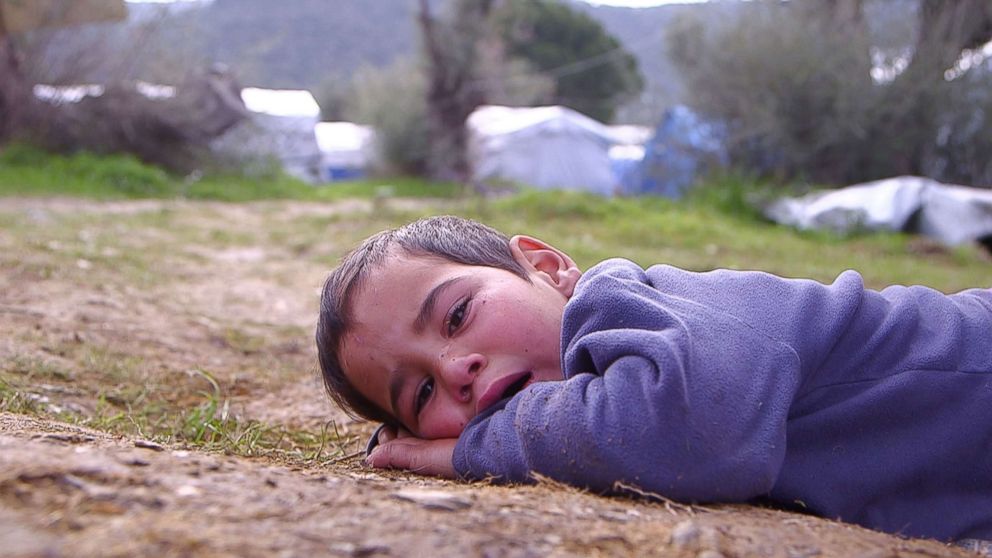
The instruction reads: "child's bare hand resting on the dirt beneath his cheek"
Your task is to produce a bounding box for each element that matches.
[365,428,458,479]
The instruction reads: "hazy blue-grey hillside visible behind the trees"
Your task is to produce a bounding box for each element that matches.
[132,0,704,120]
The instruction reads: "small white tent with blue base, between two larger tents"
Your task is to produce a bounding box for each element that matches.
[314,122,375,181]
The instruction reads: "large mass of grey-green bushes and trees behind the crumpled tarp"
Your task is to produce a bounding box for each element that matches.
[668,0,992,189]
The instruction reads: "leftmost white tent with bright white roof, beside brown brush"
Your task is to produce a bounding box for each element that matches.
[213,87,320,182]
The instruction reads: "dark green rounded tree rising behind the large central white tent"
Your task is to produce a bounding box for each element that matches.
[497,0,644,122]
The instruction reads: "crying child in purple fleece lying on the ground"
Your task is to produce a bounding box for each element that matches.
[317,217,992,540]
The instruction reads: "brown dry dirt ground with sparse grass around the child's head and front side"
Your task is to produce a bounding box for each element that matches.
[0,199,973,558]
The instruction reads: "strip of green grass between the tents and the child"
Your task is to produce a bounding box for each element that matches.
[0,145,989,291]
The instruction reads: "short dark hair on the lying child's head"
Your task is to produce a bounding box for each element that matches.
[316,215,530,425]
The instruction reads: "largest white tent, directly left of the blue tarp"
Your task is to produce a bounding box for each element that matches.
[468,105,617,195]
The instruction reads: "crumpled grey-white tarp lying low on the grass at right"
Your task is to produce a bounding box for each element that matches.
[765,176,992,246]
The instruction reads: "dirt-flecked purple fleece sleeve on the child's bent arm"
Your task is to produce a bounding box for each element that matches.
[454,262,863,502]
